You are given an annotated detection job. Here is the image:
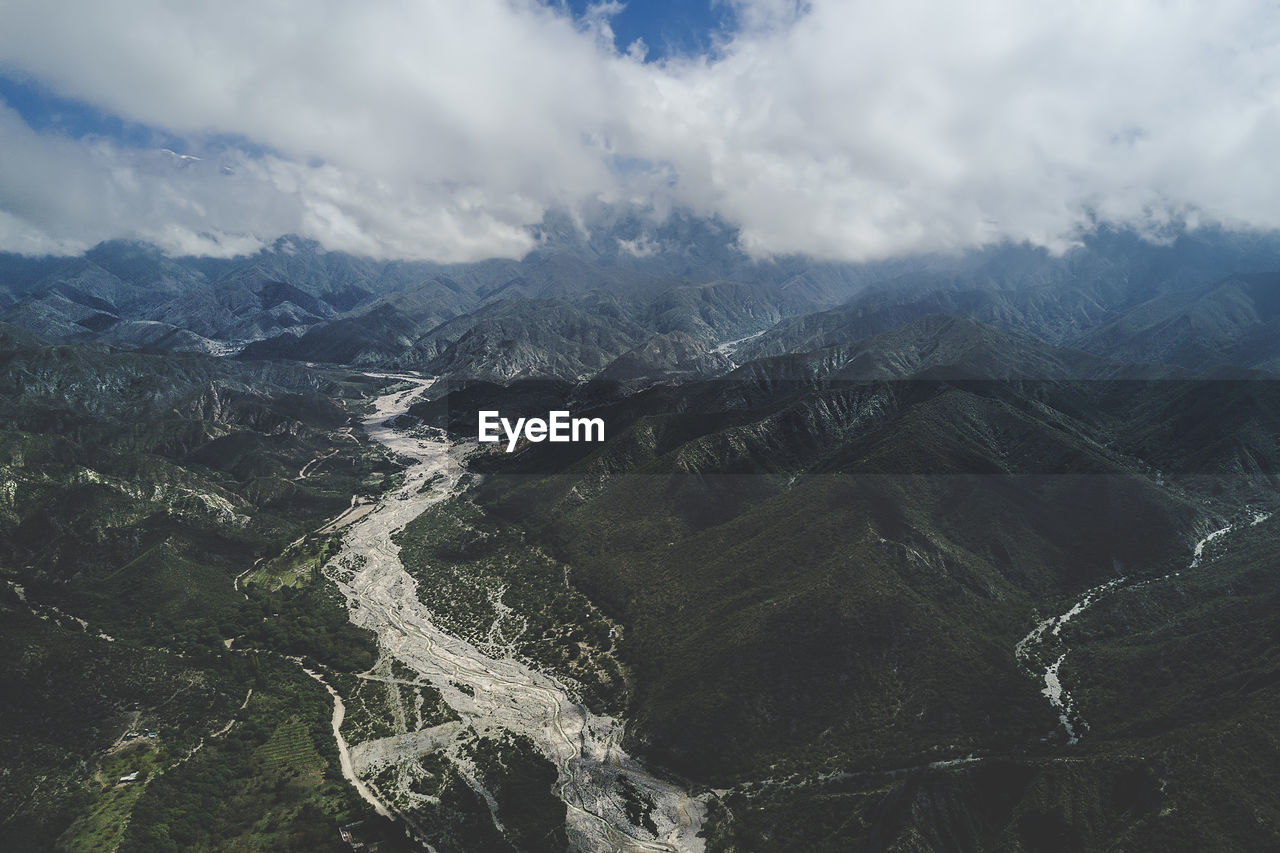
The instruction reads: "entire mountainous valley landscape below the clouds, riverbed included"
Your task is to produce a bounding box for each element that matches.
[0,222,1280,853]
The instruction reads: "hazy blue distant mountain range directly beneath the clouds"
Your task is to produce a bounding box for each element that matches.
[10,217,1280,378]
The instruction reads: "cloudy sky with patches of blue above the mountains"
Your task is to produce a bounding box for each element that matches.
[0,0,1280,263]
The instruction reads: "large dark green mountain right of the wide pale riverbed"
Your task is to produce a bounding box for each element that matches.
[404,316,1280,850]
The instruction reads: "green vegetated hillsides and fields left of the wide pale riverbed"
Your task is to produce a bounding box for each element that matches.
[0,343,409,850]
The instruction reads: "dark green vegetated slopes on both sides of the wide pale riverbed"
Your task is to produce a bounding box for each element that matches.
[12,268,1280,853]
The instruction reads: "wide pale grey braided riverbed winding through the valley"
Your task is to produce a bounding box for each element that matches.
[312,374,707,853]
